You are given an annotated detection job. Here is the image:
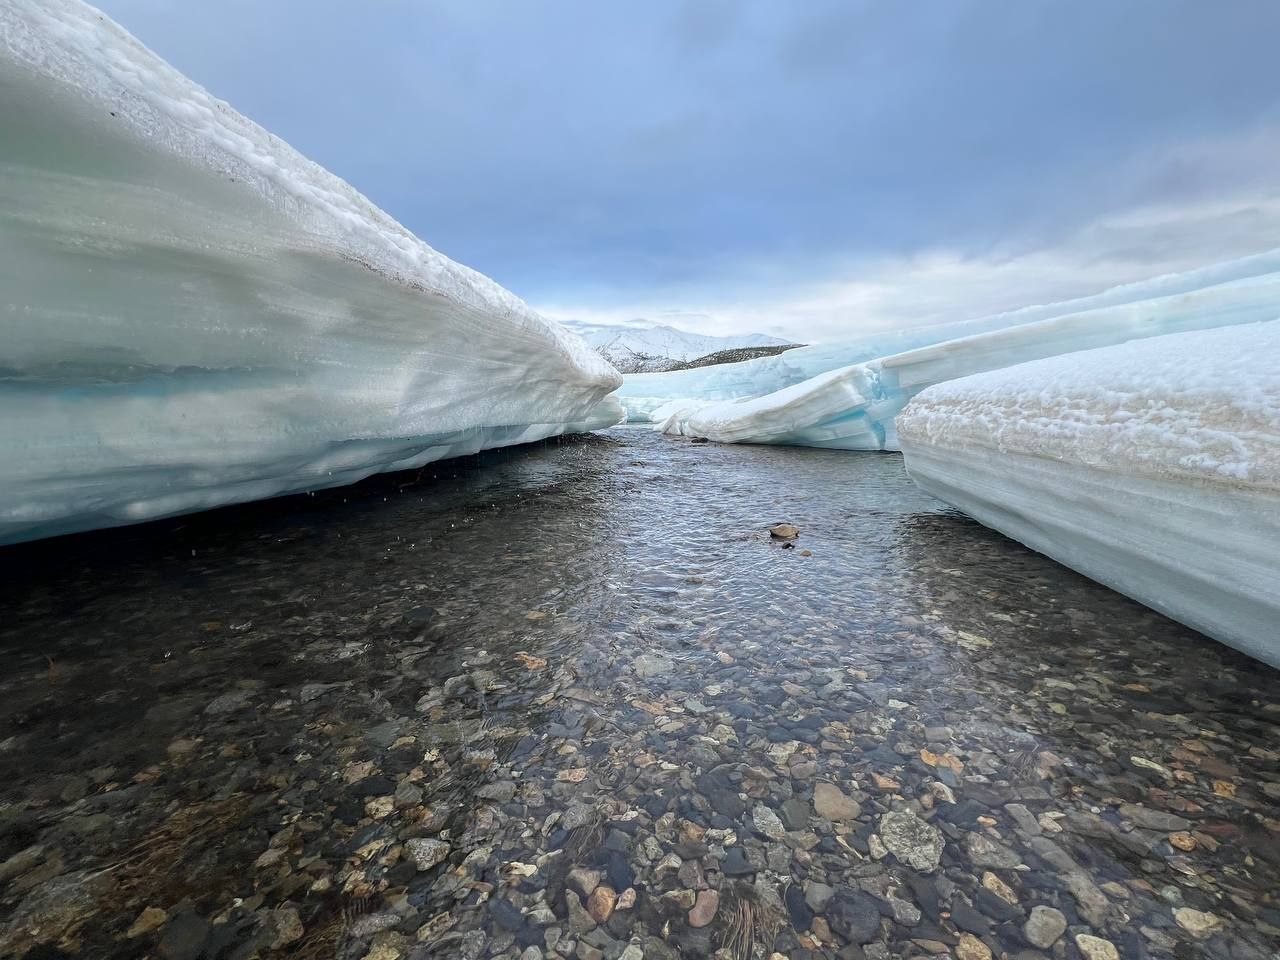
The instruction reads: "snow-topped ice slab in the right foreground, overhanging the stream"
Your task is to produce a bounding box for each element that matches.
[899,320,1280,667]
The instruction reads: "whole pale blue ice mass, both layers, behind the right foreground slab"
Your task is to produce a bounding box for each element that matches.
[620,251,1280,449]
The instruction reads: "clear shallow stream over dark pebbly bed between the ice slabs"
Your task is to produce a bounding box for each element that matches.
[0,430,1280,960]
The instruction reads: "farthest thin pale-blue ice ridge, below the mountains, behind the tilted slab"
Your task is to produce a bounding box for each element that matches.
[618,250,1280,422]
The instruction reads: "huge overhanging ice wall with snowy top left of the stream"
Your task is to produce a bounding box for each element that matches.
[0,0,622,543]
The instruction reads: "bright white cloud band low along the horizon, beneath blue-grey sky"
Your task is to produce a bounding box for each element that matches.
[535,181,1280,343]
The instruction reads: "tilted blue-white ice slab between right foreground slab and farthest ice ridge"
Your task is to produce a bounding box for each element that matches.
[652,267,1280,449]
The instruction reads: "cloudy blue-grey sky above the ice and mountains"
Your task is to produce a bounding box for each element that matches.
[99,0,1280,342]
